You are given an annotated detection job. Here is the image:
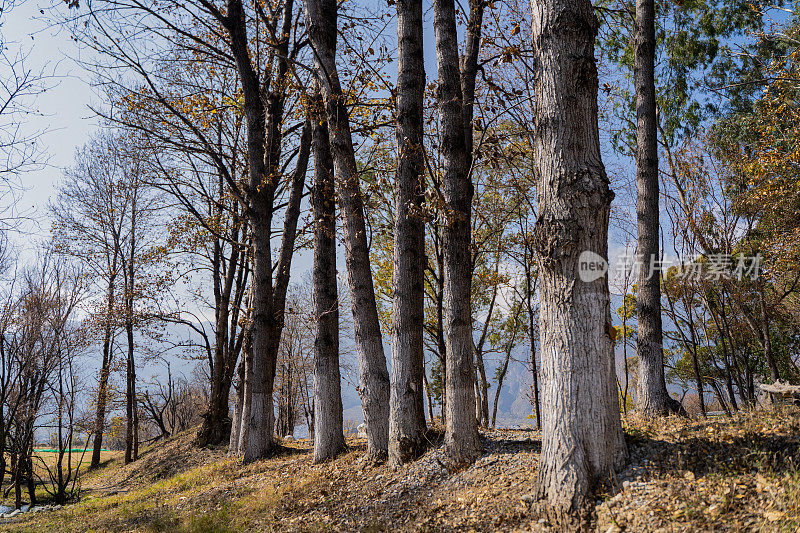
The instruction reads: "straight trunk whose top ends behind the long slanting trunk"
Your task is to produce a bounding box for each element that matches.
[311,96,345,463]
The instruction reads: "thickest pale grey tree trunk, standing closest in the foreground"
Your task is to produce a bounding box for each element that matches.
[531,0,627,527]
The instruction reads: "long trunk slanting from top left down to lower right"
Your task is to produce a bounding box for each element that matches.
[306,0,389,461]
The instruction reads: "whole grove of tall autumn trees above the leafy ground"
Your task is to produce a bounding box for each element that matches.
[0,0,800,527]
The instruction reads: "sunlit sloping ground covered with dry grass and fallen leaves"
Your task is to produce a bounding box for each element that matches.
[0,408,800,533]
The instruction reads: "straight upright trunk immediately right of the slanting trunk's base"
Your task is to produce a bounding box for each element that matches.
[389,0,425,464]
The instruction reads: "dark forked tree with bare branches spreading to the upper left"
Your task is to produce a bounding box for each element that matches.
[75,0,310,462]
